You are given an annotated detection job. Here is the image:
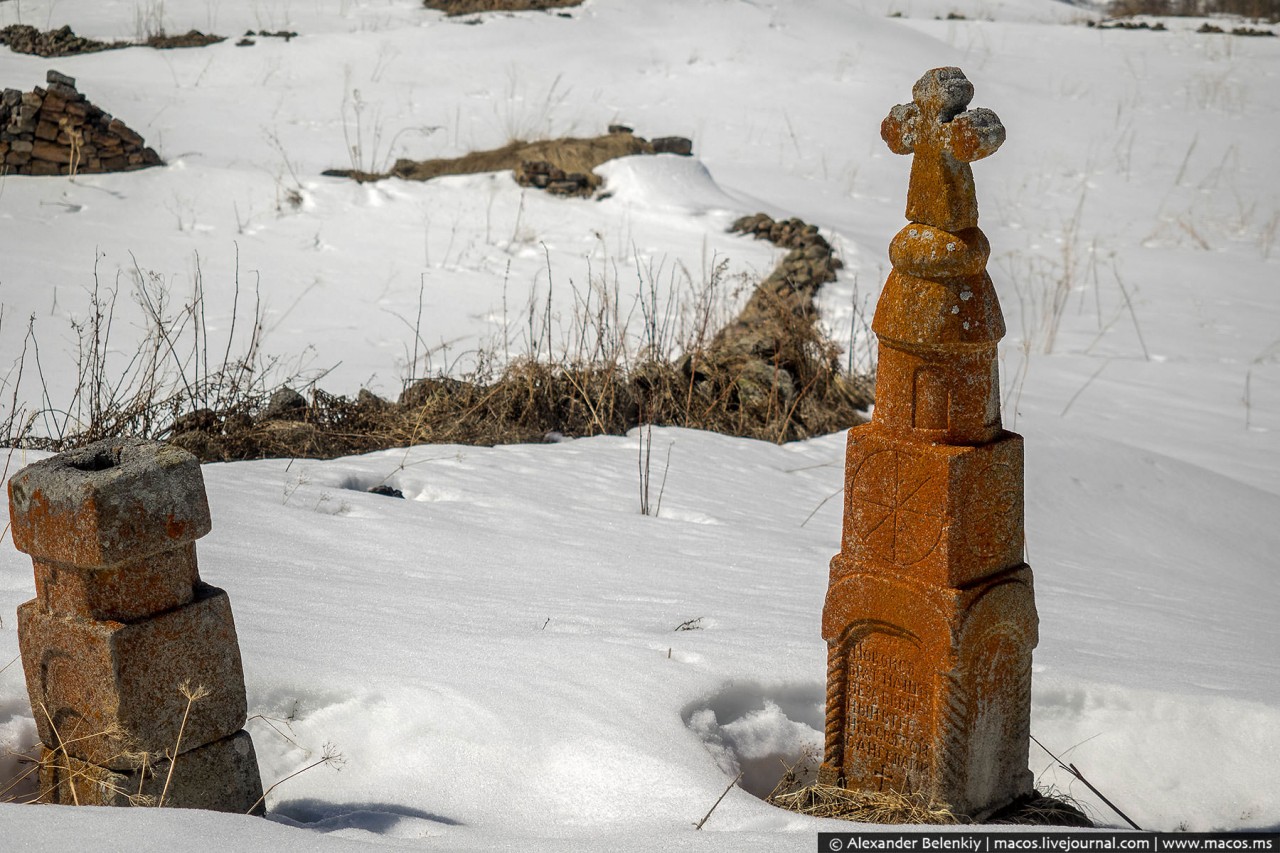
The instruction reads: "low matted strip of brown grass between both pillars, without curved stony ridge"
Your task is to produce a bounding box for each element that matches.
[168,322,870,461]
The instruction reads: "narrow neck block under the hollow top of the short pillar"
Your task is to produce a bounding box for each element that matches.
[33,542,200,622]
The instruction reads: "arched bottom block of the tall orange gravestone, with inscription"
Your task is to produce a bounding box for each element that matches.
[819,557,1038,820]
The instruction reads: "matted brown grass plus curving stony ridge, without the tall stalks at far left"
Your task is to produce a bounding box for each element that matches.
[154,214,873,460]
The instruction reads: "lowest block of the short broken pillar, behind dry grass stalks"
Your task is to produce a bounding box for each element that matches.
[40,731,266,815]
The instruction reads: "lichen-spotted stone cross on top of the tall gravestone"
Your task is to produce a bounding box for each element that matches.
[881,68,1005,233]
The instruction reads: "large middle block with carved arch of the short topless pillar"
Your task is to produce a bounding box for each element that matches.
[18,585,247,770]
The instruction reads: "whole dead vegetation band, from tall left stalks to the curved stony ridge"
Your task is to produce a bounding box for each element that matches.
[0,214,873,461]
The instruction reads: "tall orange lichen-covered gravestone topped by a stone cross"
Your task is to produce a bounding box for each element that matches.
[819,68,1038,820]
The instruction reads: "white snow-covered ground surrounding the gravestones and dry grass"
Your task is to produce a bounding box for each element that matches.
[0,0,1280,850]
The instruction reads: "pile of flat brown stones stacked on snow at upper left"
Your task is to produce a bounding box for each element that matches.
[0,70,161,175]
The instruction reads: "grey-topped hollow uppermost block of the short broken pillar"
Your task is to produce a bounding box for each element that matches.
[9,438,211,567]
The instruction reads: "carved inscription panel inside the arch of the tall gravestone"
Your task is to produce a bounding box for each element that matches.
[845,633,933,792]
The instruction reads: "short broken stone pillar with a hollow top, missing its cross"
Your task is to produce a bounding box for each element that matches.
[9,438,264,813]
